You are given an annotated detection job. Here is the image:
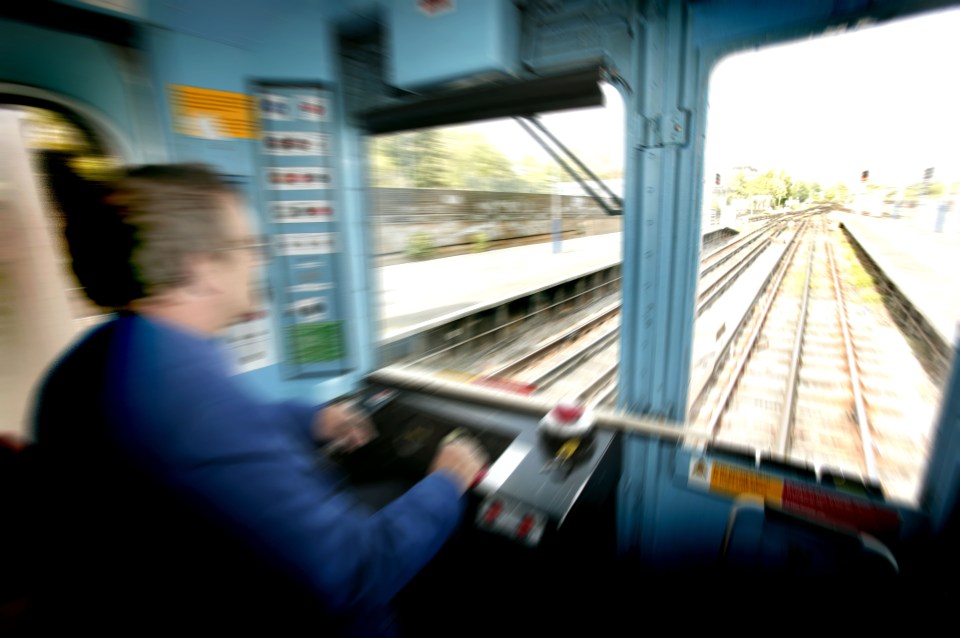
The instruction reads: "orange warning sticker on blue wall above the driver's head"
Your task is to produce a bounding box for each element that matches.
[169,84,258,139]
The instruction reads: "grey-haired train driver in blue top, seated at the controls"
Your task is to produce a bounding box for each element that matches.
[35,162,486,635]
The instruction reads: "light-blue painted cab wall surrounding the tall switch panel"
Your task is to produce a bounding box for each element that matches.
[135,3,375,402]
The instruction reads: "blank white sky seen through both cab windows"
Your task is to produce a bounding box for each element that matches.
[468,9,960,187]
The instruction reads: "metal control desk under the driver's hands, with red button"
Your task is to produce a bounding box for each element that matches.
[342,388,620,548]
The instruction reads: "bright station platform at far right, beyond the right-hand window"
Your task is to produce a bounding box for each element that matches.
[834,213,960,347]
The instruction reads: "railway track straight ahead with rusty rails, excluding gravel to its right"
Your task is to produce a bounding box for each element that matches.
[693,221,877,483]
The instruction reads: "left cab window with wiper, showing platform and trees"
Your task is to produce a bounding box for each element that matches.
[370,89,624,412]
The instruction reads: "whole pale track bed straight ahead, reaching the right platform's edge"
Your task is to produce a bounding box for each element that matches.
[689,219,929,502]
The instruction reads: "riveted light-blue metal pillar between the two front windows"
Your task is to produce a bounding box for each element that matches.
[618,0,705,553]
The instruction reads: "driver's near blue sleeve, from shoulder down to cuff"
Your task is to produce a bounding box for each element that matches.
[118,324,464,611]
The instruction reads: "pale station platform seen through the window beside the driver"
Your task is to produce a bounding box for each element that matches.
[376,233,623,341]
